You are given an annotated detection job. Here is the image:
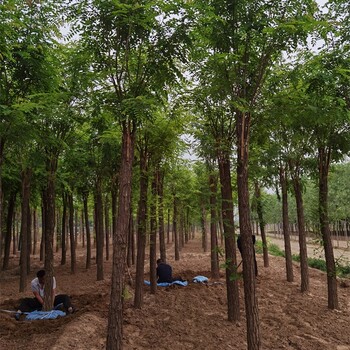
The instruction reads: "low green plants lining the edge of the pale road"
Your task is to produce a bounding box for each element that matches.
[256,241,350,278]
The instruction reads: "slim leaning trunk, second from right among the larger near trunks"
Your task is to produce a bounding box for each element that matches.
[292,168,309,292]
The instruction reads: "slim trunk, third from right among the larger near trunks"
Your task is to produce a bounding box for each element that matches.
[280,166,294,282]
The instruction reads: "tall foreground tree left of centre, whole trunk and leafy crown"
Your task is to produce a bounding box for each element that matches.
[69,1,191,349]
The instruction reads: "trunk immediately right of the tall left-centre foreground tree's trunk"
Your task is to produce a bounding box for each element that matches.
[134,149,148,309]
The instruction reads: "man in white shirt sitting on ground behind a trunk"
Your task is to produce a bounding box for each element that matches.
[18,270,74,313]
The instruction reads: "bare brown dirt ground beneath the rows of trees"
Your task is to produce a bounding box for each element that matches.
[0,240,350,350]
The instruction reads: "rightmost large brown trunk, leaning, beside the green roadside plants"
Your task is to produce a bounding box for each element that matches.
[318,148,338,310]
